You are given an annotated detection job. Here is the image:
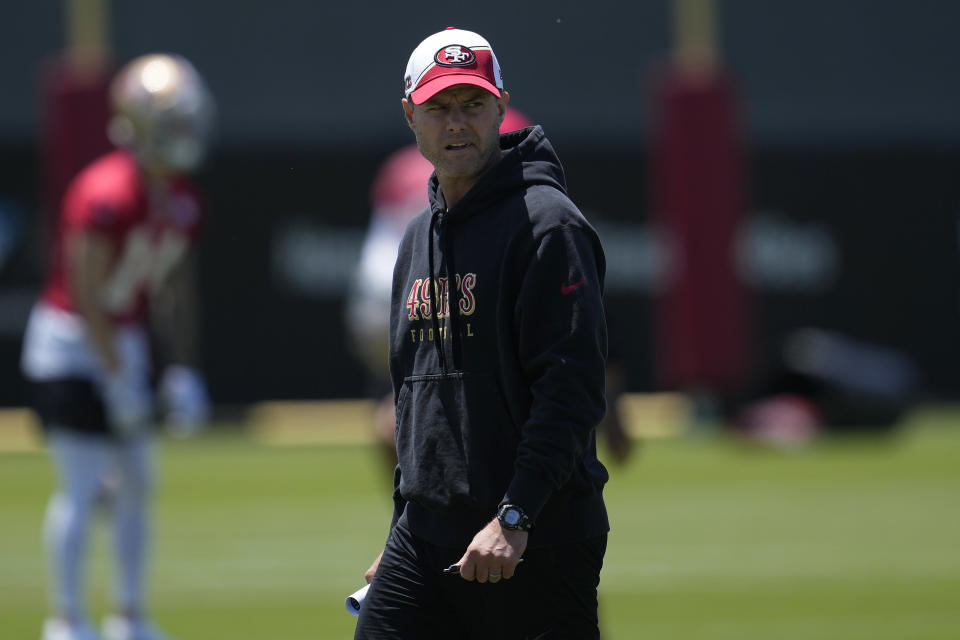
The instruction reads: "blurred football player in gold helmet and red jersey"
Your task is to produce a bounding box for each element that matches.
[22,55,213,640]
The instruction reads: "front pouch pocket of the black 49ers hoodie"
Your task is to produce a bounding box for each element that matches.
[397,373,519,510]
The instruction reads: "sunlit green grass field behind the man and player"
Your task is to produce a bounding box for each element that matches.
[0,411,960,640]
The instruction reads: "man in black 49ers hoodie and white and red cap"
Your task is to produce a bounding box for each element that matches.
[355,28,609,640]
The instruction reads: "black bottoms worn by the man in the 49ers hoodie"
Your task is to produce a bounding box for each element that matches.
[354,524,607,640]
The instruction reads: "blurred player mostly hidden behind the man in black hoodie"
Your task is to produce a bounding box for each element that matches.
[346,107,533,478]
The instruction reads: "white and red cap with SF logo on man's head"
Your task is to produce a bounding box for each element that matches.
[403,27,503,104]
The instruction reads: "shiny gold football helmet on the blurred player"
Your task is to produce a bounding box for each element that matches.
[109,54,214,172]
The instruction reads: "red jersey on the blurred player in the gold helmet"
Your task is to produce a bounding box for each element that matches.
[43,151,203,324]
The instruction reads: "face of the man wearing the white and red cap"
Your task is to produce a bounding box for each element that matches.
[403,84,510,183]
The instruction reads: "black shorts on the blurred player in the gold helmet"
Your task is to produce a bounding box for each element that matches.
[32,378,113,437]
